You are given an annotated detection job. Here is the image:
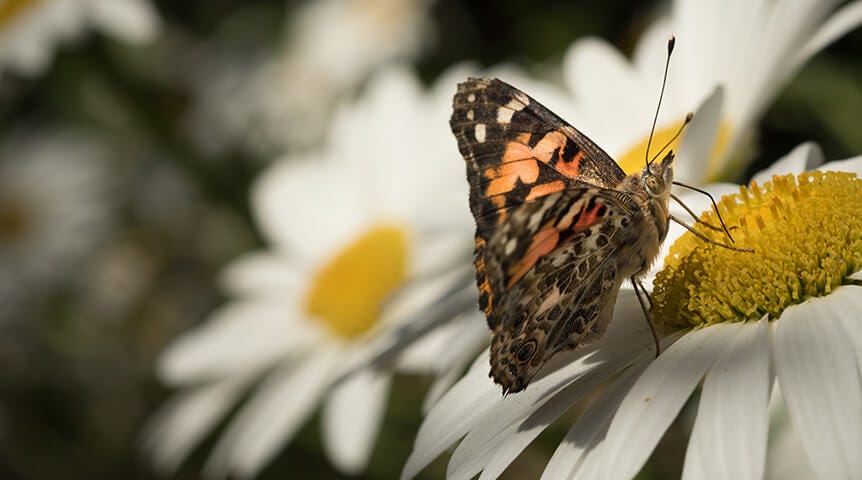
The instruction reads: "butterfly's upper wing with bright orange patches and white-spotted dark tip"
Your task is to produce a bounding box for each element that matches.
[449,78,625,329]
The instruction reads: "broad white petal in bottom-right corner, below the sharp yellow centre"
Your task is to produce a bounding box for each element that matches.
[774,295,862,478]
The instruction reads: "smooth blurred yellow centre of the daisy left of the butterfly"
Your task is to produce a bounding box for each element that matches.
[305,225,409,338]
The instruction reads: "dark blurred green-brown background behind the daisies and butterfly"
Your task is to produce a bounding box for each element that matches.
[0,0,862,479]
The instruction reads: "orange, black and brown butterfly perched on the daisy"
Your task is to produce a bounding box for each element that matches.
[449,78,674,394]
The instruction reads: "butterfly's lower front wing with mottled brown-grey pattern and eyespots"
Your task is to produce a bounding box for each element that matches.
[484,186,644,392]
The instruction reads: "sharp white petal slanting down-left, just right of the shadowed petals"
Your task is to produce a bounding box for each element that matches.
[603,324,739,478]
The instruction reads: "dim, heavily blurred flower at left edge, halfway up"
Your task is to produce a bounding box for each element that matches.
[0,131,111,316]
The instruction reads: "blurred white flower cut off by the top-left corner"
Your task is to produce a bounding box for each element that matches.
[0,0,159,75]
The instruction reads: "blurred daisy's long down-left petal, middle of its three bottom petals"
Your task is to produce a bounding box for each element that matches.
[205,349,339,478]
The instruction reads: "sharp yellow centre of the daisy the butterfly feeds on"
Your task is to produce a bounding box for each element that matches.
[652,171,862,330]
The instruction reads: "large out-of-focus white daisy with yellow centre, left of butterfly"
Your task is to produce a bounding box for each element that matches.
[143,68,477,477]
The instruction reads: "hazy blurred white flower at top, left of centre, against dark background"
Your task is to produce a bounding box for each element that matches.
[190,0,432,157]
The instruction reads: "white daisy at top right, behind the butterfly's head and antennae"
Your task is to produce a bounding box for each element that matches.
[563,0,862,183]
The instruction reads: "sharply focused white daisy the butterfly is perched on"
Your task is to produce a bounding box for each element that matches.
[403,145,862,479]
